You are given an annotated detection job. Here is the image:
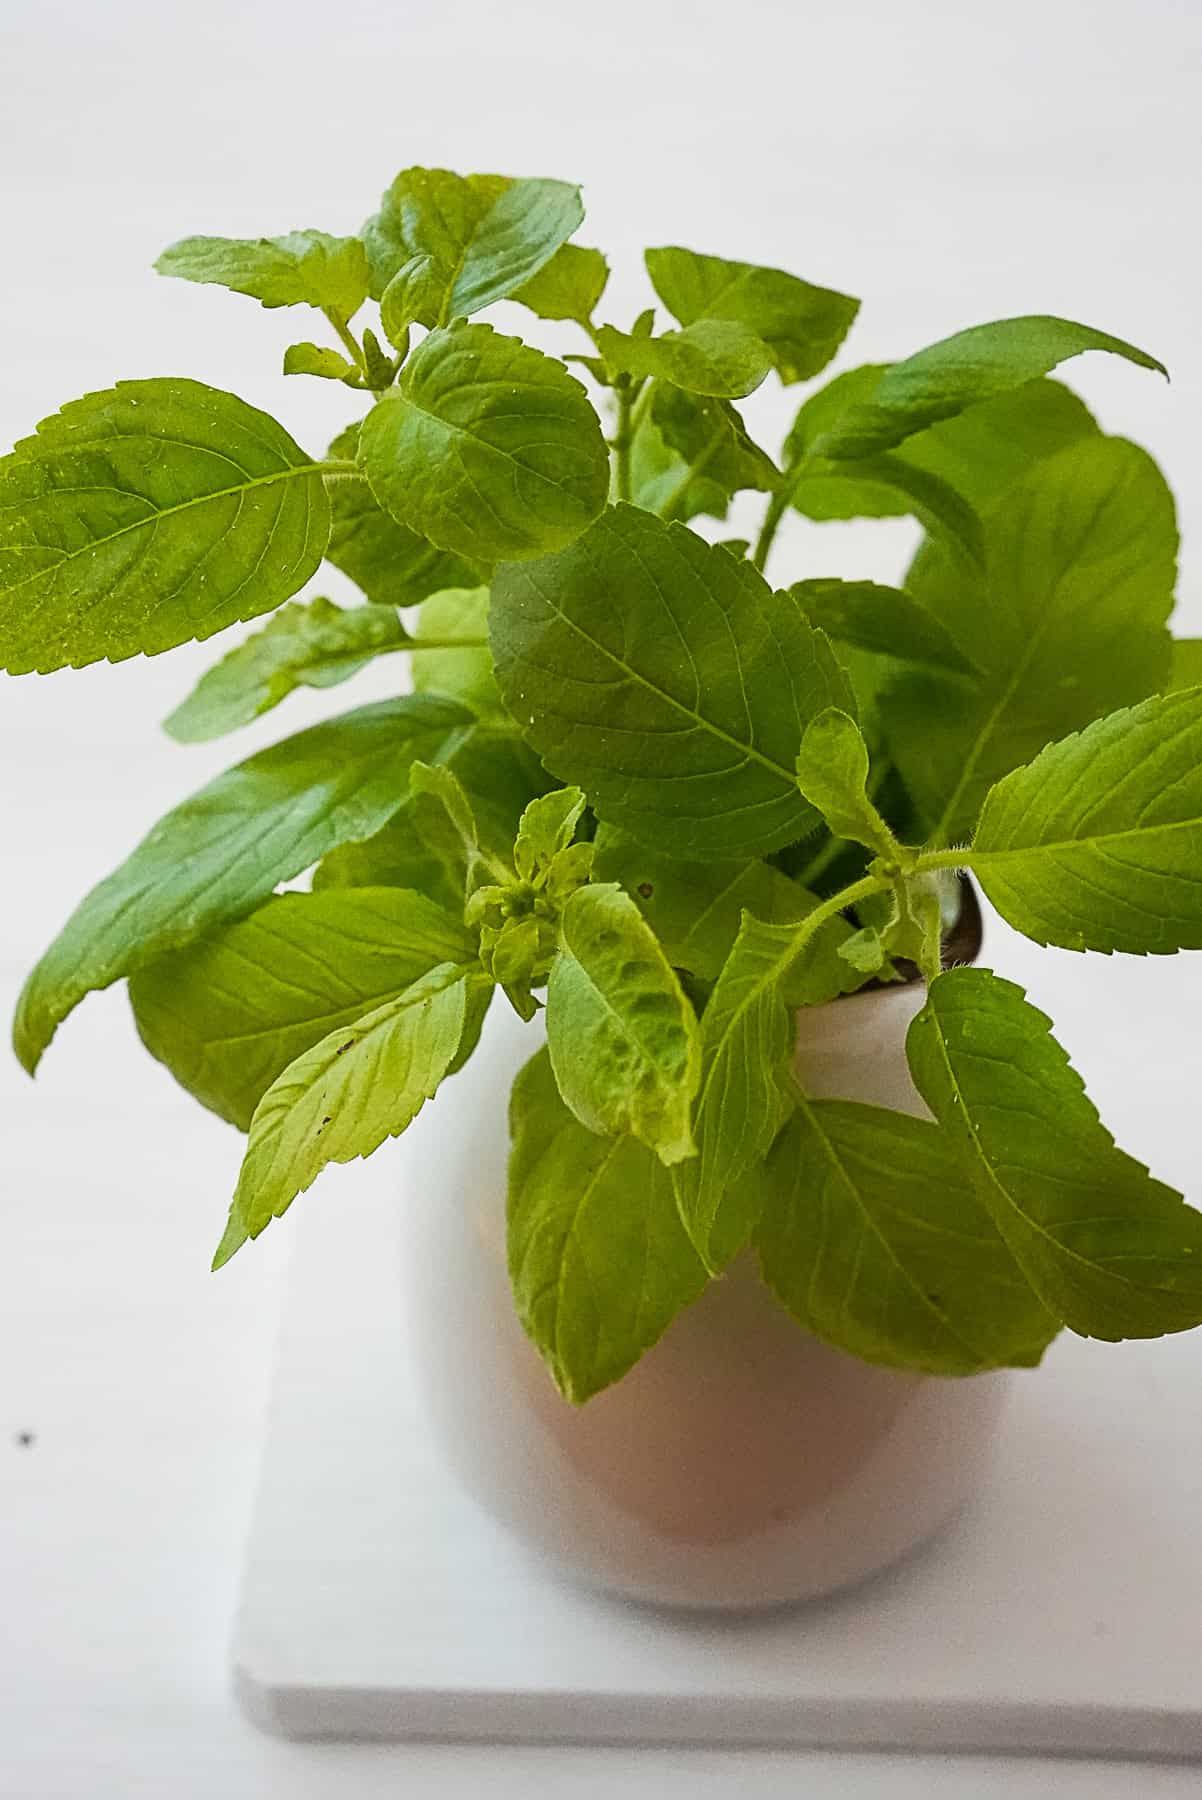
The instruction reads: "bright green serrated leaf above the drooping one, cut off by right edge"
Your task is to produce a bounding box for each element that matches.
[964,689,1202,956]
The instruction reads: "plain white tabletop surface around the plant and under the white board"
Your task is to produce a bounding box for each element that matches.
[0,0,1202,1800]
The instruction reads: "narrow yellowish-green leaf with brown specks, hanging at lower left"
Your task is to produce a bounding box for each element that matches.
[214,963,484,1267]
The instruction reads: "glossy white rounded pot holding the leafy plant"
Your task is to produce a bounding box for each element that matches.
[403,983,1009,1607]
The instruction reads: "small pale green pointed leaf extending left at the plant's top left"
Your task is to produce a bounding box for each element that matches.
[155,230,367,320]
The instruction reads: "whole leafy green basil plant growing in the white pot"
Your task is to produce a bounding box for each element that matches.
[9,169,1202,1400]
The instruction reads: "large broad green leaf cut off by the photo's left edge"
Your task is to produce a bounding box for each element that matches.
[0,380,329,675]
